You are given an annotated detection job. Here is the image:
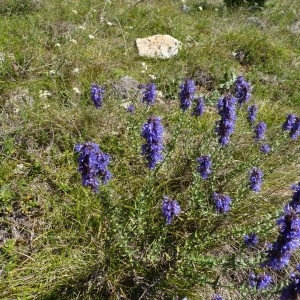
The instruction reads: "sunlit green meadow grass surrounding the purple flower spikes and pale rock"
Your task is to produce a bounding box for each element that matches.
[0,0,300,300]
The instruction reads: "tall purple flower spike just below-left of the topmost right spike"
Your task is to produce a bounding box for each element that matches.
[216,95,236,146]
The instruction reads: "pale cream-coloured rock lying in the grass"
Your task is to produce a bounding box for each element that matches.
[136,34,182,59]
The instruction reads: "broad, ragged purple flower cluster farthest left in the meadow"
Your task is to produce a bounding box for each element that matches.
[74,142,112,192]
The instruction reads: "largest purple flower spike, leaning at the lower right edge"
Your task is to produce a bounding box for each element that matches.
[262,206,300,270]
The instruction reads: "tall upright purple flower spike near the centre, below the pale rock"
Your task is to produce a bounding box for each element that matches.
[142,117,164,169]
